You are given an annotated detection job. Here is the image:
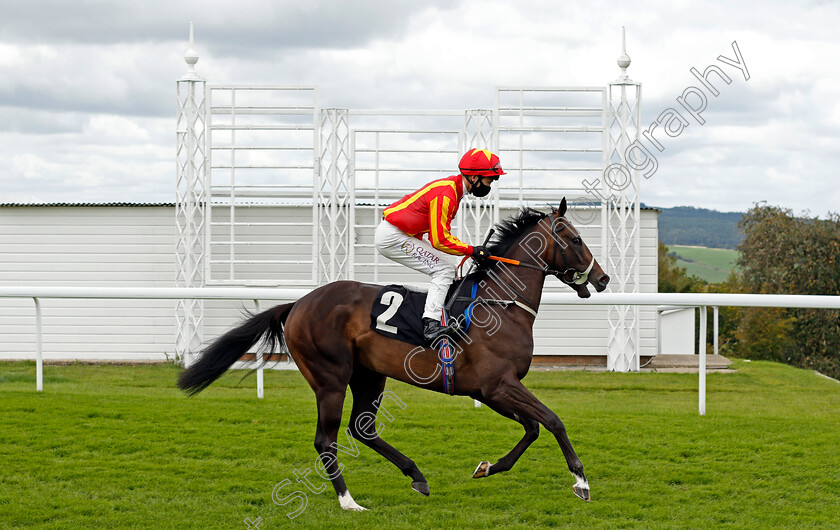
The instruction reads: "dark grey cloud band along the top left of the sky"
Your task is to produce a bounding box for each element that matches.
[0,0,460,50]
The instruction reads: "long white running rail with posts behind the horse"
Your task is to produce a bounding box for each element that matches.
[0,287,840,415]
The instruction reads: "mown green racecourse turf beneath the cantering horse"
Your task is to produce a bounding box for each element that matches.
[0,361,840,530]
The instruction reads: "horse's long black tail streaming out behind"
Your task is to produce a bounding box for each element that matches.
[178,303,295,396]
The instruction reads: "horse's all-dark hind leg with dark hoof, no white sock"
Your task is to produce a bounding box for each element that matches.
[348,364,429,495]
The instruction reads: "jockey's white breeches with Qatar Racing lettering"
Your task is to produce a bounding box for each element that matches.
[374,219,455,321]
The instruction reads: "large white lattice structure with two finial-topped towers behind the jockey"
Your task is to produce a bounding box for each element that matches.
[178,26,641,371]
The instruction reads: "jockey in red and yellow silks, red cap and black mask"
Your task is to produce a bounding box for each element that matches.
[374,149,506,343]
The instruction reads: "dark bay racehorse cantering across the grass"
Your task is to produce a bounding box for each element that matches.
[178,198,609,510]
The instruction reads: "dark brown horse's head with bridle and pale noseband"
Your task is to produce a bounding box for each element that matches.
[543,197,610,298]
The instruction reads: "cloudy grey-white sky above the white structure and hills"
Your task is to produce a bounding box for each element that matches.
[0,0,840,215]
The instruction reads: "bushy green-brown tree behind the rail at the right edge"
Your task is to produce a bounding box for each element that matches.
[736,205,840,377]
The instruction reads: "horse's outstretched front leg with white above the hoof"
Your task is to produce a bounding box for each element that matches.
[476,376,589,502]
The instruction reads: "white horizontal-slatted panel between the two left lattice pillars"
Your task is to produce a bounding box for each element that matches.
[204,86,320,285]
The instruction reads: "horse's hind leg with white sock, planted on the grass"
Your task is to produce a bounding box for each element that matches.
[315,387,365,511]
